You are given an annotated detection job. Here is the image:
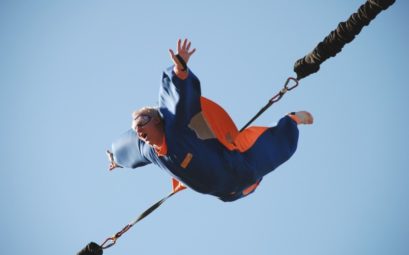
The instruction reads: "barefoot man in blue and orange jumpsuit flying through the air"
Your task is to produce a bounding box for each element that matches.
[109,39,313,201]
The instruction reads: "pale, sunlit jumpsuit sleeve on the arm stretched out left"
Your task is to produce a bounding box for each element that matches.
[112,129,151,168]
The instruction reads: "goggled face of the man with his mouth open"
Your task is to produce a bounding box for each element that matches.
[135,114,163,146]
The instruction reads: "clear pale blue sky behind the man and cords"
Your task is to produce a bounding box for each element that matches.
[0,0,409,255]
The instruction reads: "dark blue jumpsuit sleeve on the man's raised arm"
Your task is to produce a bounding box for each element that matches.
[159,66,201,126]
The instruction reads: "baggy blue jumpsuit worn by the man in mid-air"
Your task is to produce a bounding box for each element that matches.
[112,67,298,201]
